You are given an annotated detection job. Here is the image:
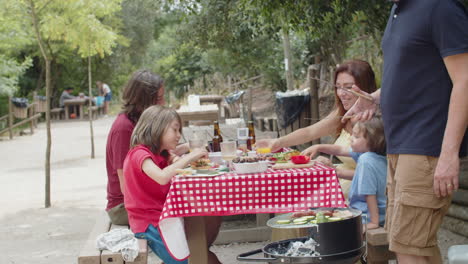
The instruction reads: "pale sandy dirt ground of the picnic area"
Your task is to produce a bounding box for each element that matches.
[0,117,468,264]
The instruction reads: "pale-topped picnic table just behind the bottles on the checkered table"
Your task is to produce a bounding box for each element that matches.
[177,104,219,126]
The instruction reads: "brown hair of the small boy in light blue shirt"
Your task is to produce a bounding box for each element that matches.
[355,115,387,155]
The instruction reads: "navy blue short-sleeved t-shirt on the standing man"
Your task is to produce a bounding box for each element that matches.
[380,0,468,156]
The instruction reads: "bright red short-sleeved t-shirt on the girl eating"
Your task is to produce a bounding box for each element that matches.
[124,145,171,233]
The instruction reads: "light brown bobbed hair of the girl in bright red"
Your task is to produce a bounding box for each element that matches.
[130,105,182,157]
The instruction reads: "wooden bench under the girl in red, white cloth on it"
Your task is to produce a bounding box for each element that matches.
[78,211,148,264]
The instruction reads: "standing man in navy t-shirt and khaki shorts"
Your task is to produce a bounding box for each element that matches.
[344,0,468,263]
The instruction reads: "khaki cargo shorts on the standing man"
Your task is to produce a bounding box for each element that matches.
[385,154,451,257]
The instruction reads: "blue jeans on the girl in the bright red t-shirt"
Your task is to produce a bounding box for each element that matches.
[135,224,188,264]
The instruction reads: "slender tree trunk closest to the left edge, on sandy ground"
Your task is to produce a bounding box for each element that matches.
[29,0,52,208]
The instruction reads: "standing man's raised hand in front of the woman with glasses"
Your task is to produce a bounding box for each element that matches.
[341,85,378,123]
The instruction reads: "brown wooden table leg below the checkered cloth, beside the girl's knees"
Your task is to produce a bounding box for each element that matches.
[184,216,208,264]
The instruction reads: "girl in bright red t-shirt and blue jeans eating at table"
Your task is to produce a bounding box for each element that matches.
[123,105,208,264]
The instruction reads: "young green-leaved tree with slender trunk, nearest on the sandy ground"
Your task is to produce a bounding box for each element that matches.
[14,0,120,207]
